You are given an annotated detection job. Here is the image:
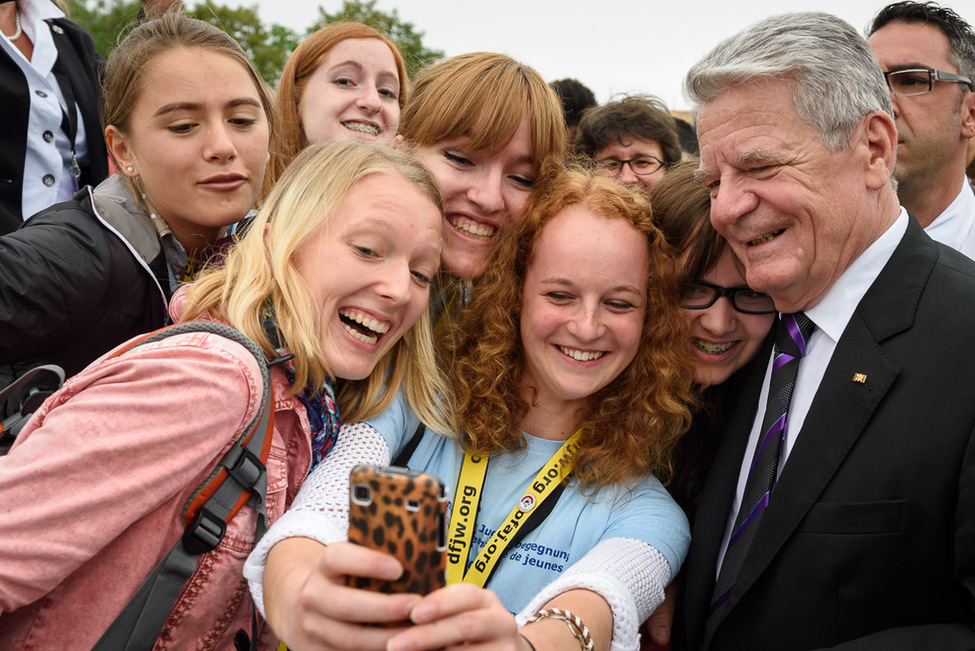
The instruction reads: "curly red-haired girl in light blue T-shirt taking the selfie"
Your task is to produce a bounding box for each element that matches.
[245,169,693,651]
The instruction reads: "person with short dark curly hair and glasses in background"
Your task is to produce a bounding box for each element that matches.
[575,95,682,188]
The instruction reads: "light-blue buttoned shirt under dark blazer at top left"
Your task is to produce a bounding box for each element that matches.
[0,0,88,219]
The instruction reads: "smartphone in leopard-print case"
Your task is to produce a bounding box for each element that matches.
[349,465,447,595]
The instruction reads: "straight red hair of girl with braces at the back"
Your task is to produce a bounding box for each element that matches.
[261,23,409,196]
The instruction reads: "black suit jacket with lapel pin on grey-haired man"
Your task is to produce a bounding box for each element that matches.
[682,218,975,651]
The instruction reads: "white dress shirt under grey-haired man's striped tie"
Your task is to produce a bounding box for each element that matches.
[718,208,910,572]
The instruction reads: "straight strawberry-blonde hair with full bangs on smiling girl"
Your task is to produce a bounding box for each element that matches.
[399,52,566,174]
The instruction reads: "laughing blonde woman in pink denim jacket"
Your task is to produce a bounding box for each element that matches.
[0,143,443,649]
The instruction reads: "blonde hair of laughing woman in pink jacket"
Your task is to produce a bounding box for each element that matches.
[183,142,445,427]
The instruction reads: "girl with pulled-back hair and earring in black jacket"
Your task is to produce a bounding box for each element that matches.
[0,13,273,384]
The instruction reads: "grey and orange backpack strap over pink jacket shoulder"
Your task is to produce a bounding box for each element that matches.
[94,321,284,651]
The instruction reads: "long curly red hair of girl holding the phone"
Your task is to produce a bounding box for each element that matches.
[444,169,694,487]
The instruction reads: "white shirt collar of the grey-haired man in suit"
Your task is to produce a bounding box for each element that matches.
[805,208,910,342]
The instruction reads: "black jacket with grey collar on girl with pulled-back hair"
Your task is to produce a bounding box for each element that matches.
[0,176,170,386]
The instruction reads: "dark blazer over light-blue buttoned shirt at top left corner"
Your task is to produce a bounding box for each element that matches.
[0,18,108,235]
